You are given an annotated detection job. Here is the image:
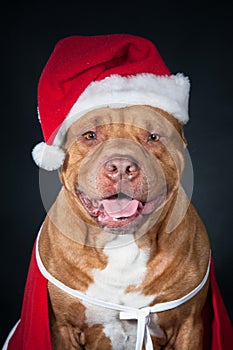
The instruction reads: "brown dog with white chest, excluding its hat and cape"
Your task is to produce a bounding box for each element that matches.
[38,105,210,350]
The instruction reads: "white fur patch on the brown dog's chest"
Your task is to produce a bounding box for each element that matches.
[85,236,157,350]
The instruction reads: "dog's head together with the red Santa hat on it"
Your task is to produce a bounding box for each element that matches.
[33,34,190,241]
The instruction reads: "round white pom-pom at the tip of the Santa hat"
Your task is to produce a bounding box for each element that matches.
[32,142,65,171]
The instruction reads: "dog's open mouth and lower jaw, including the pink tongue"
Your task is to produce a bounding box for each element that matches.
[76,190,166,234]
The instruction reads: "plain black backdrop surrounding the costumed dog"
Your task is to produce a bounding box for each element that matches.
[0,1,233,342]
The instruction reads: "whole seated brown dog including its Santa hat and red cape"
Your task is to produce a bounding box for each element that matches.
[3,34,220,350]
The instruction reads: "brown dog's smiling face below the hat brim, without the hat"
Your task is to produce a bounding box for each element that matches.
[61,106,185,233]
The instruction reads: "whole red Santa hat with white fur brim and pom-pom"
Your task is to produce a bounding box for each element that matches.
[32,34,190,170]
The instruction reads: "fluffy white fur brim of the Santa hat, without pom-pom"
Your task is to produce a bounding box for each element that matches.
[53,73,190,146]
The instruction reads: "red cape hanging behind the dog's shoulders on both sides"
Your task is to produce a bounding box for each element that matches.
[6,242,233,350]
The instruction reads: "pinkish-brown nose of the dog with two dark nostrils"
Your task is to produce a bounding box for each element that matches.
[105,157,139,181]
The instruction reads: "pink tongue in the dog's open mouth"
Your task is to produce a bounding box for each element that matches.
[102,198,139,218]
